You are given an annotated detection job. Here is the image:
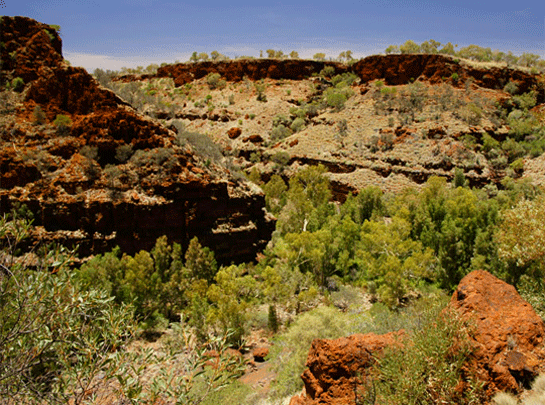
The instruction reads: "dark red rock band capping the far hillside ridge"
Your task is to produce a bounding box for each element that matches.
[121,54,545,102]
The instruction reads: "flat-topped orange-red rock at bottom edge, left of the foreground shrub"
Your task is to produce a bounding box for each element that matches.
[290,331,403,405]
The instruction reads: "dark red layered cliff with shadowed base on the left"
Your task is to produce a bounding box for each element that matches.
[0,17,274,263]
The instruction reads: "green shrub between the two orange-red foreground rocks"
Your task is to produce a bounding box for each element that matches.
[374,312,484,404]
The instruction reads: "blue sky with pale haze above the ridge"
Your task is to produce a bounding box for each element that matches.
[0,0,545,72]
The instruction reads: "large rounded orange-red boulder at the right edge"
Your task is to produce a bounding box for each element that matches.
[449,271,545,392]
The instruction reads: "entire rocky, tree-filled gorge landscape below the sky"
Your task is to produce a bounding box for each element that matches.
[5,17,545,405]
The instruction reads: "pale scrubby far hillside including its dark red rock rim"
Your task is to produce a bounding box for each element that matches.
[108,54,545,199]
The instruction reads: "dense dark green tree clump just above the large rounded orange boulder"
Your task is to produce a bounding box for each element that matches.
[397,177,498,289]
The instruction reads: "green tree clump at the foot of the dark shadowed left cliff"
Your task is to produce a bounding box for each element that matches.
[77,237,206,327]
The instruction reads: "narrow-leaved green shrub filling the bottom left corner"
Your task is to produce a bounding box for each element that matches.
[0,216,135,403]
